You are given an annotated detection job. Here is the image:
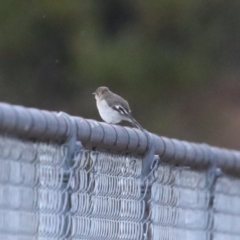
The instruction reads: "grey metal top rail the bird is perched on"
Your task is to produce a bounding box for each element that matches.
[0,103,240,173]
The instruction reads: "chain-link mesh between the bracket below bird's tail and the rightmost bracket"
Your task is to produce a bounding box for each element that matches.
[148,165,211,240]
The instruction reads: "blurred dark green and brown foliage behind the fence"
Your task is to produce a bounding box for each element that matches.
[0,0,240,148]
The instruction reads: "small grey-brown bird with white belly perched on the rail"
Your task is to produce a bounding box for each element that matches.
[93,87,143,130]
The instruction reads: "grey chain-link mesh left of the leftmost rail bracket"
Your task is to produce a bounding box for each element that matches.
[0,136,68,239]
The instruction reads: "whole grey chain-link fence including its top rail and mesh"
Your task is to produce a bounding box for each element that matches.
[0,104,240,240]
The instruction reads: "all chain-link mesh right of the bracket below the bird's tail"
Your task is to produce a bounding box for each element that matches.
[147,164,240,240]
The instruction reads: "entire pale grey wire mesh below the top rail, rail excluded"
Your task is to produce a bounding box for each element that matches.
[0,135,240,240]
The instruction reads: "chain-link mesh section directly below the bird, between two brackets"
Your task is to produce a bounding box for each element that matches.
[70,150,145,240]
